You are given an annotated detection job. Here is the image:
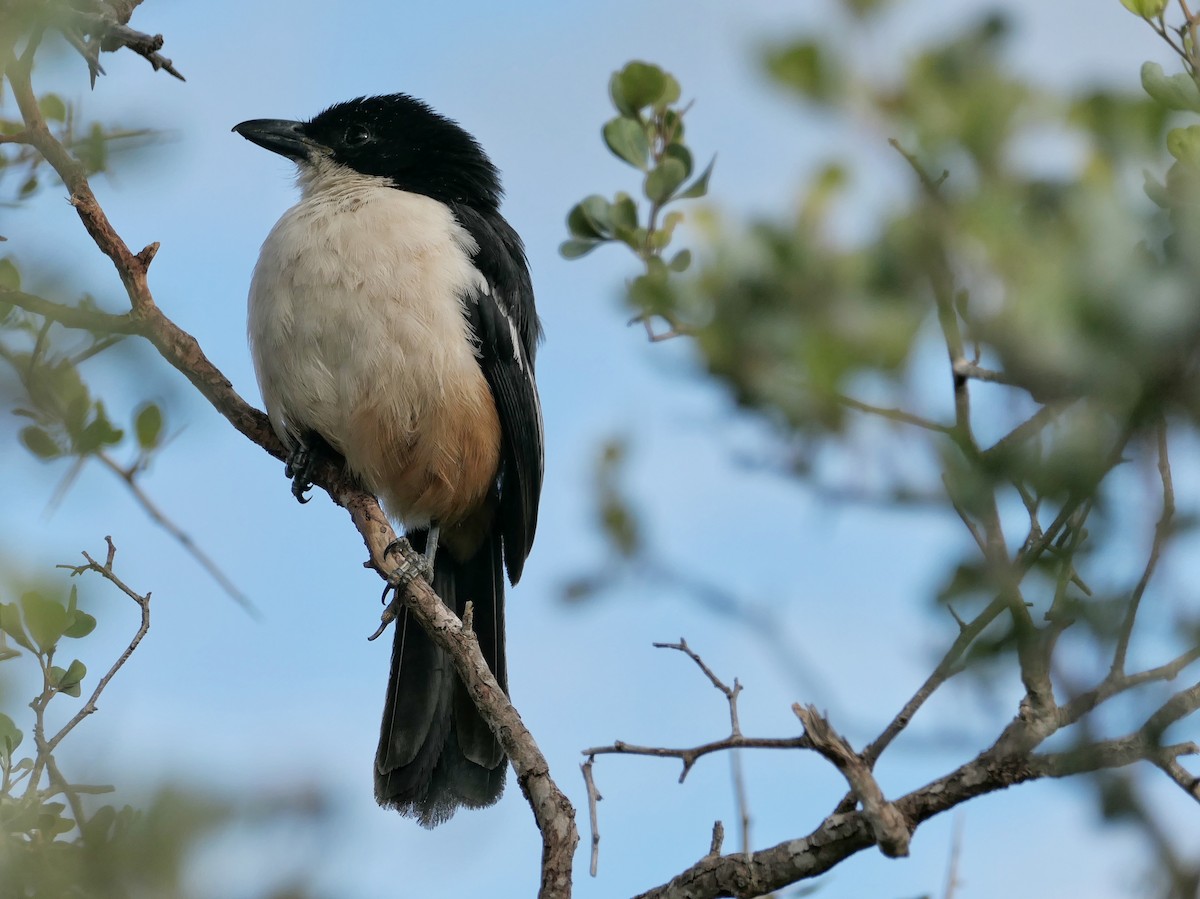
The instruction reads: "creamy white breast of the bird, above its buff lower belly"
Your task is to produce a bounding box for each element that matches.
[250,157,486,516]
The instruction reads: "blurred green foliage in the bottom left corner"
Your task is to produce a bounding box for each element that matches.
[0,559,331,899]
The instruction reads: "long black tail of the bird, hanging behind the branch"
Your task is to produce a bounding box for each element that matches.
[376,528,508,827]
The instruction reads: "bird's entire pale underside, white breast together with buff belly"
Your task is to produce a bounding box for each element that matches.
[250,169,500,528]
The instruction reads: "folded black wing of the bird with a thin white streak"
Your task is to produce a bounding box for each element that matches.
[454,206,544,583]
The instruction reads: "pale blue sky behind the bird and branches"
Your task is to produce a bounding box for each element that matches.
[0,0,1194,899]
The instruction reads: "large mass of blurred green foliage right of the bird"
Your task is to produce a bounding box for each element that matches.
[563,0,1200,897]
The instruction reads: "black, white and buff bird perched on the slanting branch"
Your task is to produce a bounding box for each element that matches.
[233,94,545,827]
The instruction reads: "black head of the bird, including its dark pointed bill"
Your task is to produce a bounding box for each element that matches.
[233,94,500,210]
